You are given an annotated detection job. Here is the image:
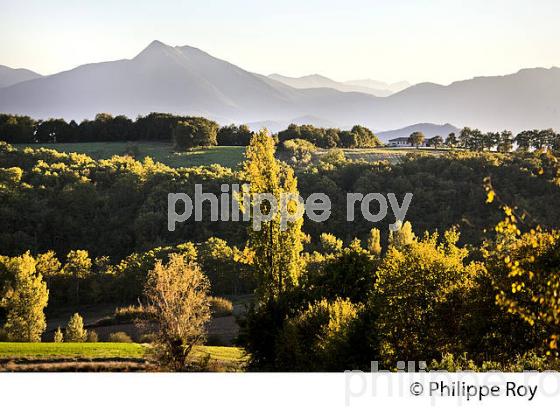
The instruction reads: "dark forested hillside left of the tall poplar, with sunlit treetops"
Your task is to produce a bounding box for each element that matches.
[0,144,245,260]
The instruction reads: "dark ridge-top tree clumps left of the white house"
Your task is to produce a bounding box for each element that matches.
[0,113,380,150]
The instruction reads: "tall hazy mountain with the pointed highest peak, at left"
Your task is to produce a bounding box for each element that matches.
[0,41,310,120]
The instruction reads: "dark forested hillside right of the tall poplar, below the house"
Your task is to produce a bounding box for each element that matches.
[298,153,560,245]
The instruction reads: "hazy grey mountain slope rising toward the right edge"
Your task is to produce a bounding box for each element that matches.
[374,67,560,131]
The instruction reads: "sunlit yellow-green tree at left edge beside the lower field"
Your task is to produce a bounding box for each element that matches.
[2,252,49,342]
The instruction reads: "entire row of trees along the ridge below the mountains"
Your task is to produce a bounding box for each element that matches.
[4,109,560,153]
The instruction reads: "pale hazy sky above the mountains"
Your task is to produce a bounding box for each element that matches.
[0,0,560,83]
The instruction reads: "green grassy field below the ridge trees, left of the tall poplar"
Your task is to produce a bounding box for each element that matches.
[15,142,245,168]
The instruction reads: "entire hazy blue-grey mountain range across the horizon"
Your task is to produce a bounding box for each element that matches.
[0,41,560,131]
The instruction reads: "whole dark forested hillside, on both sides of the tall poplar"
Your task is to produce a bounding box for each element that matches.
[0,143,560,258]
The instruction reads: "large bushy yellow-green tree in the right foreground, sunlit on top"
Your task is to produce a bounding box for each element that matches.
[373,227,483,367]
